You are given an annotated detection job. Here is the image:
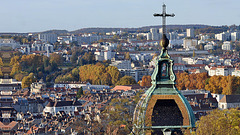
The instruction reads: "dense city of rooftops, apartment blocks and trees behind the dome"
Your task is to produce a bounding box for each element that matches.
[0,25,240,135]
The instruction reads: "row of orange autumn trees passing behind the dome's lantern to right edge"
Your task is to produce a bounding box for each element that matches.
[139,72,240,95]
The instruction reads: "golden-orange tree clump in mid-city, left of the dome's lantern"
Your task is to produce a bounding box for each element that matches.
[55,63,136,86]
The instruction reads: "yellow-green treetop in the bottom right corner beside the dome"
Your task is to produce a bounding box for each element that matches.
[193,109,240,135]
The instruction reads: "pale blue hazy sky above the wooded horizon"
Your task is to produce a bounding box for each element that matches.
[0,0,240,32]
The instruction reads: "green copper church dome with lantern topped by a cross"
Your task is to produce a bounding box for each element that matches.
[133,4,195,135]
